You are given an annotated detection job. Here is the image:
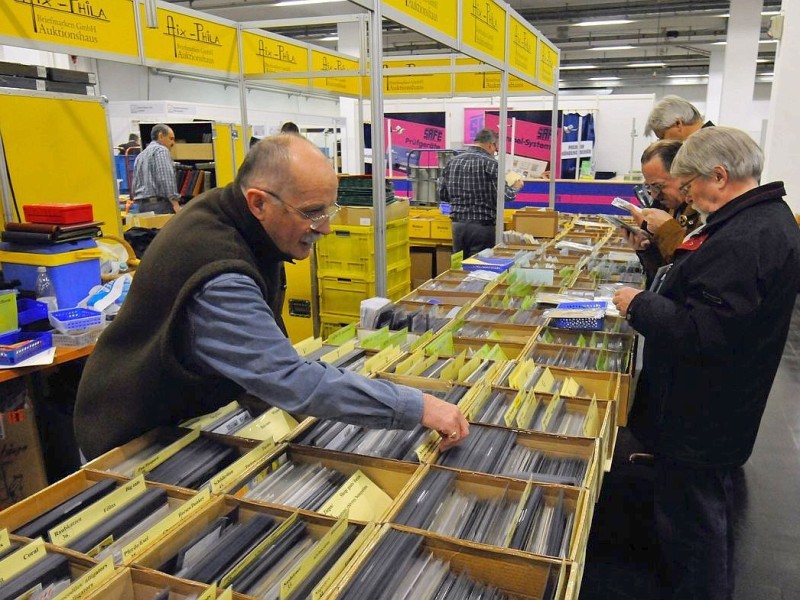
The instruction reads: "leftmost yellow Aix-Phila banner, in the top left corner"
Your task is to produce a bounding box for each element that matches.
[0,0,139,58]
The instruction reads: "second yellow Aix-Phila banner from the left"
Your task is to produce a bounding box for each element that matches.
[140,6,239,75]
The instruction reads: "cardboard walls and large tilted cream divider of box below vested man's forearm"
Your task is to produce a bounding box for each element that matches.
[229,444,419,523]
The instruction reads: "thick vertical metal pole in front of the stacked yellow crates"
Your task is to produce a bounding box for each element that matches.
[369,2,388,297]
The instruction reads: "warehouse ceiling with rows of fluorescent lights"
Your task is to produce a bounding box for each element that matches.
[167,0,781,91]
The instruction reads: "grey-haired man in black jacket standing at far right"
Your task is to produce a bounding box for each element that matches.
[614,127,800,600]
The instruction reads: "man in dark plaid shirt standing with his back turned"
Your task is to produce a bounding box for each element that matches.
[439,129,523,258]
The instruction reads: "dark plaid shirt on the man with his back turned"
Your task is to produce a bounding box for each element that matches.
[439,146,517,223]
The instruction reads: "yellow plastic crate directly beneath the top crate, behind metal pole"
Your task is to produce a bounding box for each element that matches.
[319,261,411,319]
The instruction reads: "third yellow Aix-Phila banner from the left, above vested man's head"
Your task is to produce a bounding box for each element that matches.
[242,31,309,87]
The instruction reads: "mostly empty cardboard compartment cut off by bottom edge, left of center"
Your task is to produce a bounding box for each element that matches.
[86,567,225,600]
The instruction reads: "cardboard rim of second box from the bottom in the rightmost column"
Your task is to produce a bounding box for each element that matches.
[388,465,593,561]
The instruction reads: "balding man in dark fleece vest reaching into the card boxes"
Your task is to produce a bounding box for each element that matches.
[74,134,469,458]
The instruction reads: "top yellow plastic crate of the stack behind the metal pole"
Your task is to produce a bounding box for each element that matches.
[316,218,410,281]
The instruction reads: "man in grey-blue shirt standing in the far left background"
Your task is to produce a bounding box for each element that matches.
[131,123,180,215]
